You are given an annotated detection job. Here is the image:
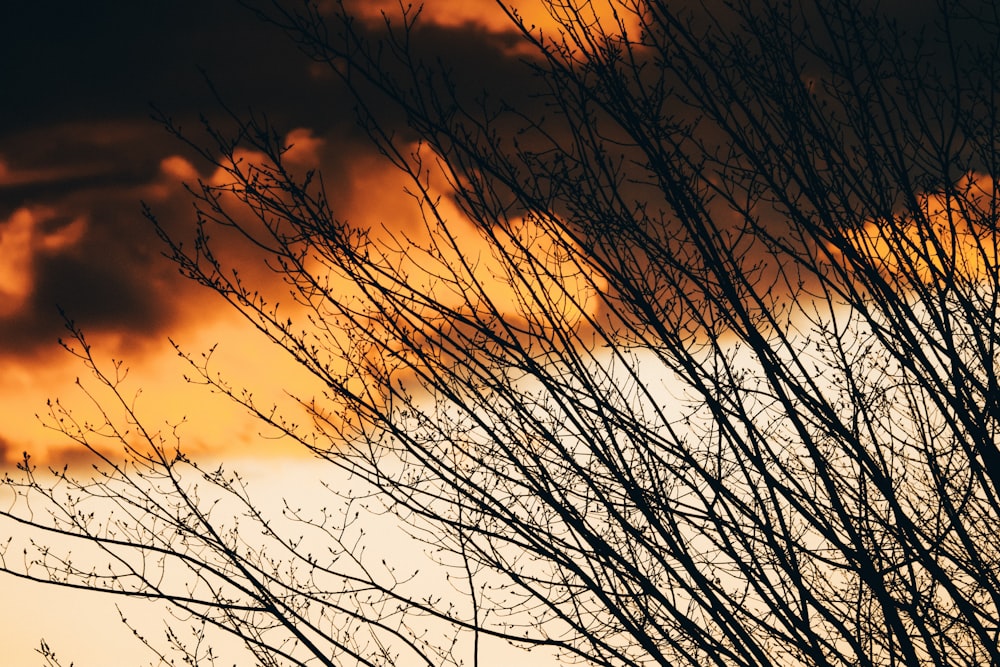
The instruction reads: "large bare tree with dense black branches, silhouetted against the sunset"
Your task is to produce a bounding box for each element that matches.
[2,0,1000,665]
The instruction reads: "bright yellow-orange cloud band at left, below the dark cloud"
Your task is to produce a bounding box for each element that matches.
[0,316,321,466]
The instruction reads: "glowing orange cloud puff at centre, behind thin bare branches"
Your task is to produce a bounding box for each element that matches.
[340,145,606,327]
